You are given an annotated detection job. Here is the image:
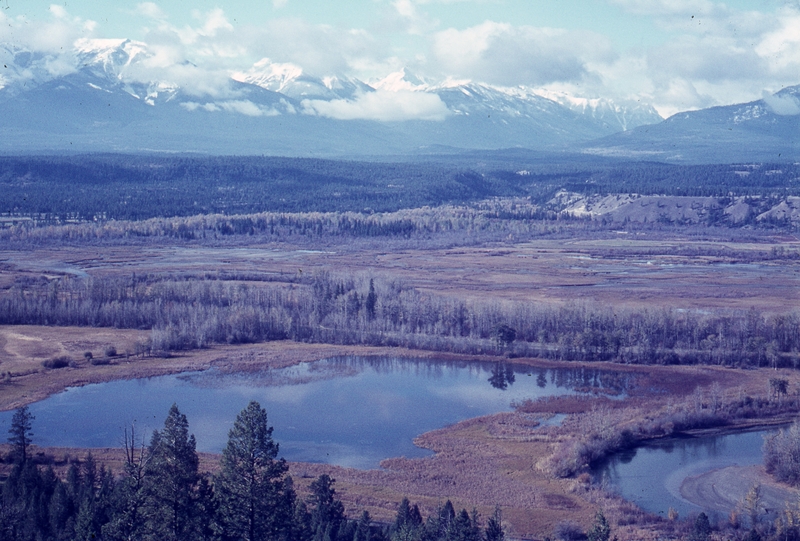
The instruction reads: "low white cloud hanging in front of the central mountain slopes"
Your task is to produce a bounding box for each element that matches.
[302,90,449,122]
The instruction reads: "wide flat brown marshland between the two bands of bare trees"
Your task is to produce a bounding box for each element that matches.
[0,232,800,313]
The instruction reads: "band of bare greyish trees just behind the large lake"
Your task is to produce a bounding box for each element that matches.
[0,273,800,367]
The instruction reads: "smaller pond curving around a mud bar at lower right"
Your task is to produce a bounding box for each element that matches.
[594,431,769,517]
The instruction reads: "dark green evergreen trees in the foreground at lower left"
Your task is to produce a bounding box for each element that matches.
[0,402,505,541]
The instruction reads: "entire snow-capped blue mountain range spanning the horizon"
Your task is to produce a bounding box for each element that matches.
[0,40,800,162]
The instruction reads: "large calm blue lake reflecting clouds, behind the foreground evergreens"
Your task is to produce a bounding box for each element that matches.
[0,357,627,468]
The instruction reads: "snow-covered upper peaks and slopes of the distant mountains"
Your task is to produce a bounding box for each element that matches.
[0,39,664,135]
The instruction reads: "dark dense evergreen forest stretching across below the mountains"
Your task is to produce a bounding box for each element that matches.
[0,155,800,223]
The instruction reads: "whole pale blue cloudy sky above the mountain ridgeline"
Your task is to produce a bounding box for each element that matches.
[0,0,800,116]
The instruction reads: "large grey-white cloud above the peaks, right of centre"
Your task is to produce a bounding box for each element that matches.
[433,21,615,86]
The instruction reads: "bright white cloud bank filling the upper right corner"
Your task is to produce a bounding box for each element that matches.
[589,0,800,115]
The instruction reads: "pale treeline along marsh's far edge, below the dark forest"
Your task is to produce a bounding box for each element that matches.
[0,198,580,244]
